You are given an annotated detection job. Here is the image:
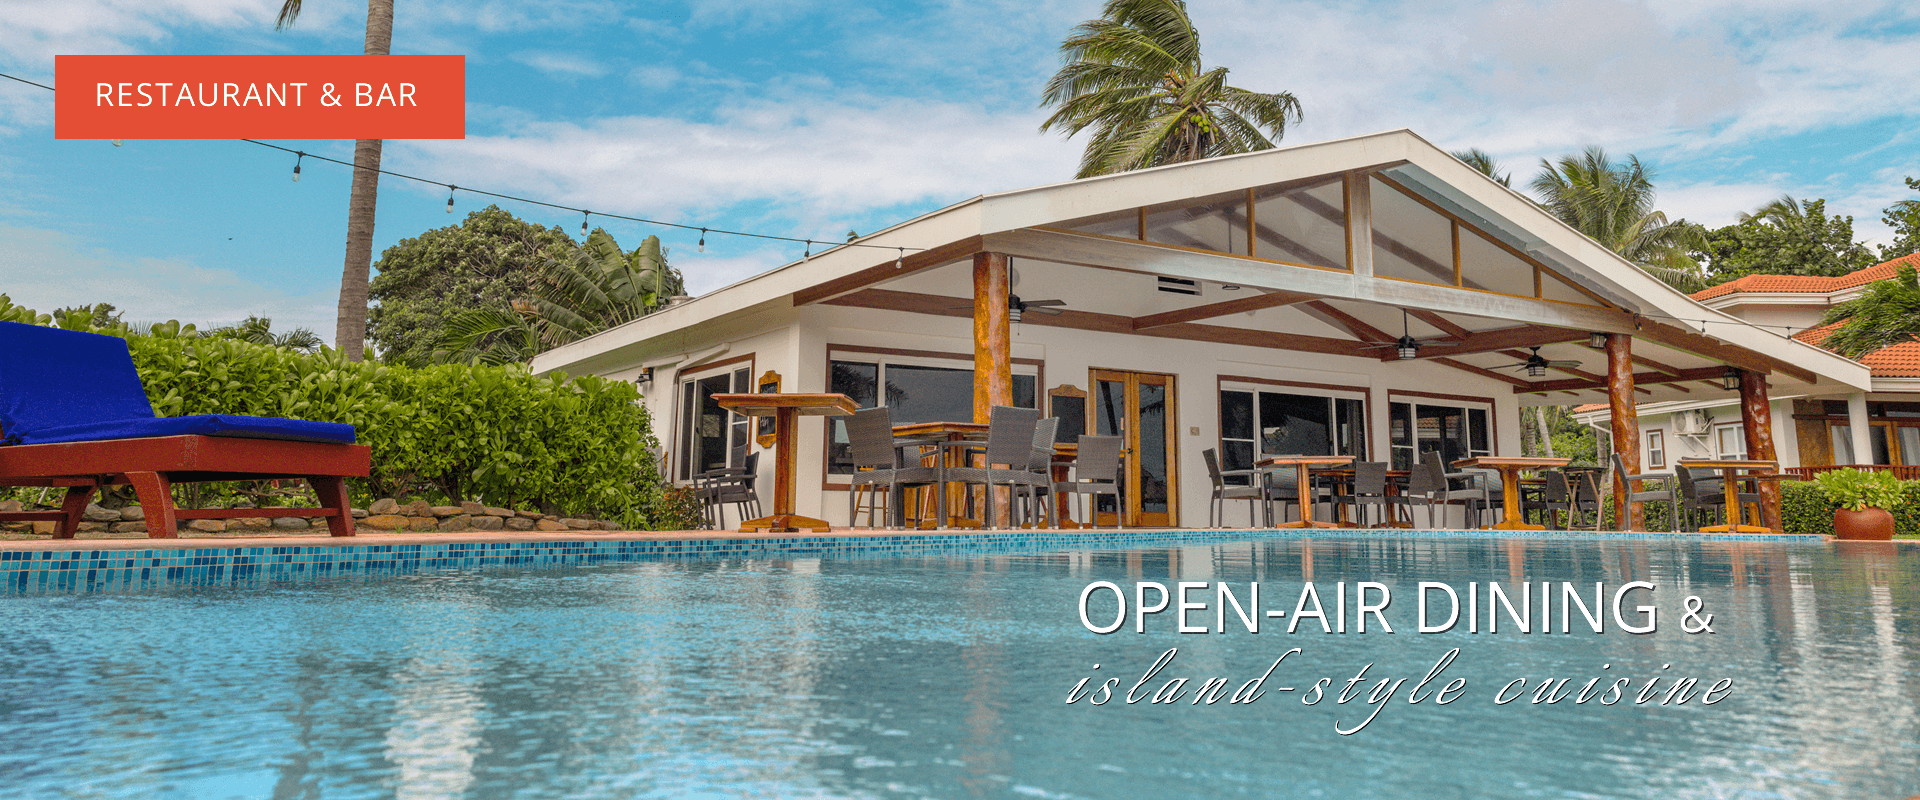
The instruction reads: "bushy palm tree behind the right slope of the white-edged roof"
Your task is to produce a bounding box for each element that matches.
[1532,148,1707,292]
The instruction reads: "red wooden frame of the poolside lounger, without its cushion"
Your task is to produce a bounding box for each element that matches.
[0,435,372,539]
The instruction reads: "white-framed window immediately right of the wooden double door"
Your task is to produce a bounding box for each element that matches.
[1219,384,1367,483]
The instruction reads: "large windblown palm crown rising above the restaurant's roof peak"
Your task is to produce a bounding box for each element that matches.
[1041,0,1300,178]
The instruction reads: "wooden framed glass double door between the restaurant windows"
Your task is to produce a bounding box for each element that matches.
[1087,370,1181,528]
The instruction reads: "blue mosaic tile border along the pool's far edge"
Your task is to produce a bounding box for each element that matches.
[0,529,1826,595]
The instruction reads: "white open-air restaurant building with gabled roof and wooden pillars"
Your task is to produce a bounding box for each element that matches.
[534,130,1868,526]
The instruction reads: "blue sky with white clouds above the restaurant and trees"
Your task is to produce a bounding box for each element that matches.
[0,0,1920,336]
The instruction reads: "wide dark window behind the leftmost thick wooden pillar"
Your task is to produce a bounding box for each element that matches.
[828,351,1039,476]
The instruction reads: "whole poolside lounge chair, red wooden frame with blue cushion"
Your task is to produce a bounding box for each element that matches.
[0,322,372,539]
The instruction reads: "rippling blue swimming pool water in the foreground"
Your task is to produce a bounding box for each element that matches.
[0,537,1920,798]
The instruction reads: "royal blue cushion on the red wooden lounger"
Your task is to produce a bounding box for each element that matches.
[0,322,353,445]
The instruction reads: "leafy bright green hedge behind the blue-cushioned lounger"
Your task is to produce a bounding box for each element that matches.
[110,329,687,528]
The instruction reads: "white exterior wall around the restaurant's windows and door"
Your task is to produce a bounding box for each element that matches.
[629,305,1521,528]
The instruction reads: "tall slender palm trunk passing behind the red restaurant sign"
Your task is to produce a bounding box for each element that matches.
[275,0,394,361]
